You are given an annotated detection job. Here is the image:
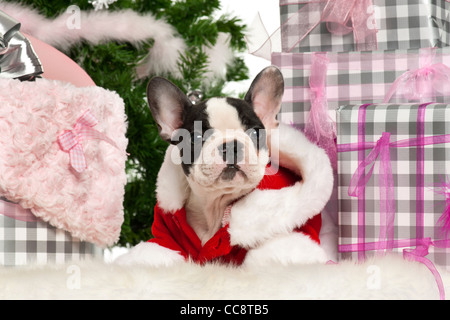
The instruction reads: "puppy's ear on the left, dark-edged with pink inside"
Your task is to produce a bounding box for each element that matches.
[147,77,192,142]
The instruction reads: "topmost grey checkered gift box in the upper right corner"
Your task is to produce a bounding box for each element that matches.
[280,0,450,53]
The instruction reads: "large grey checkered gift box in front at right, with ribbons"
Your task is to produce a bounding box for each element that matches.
[337,104,450,268]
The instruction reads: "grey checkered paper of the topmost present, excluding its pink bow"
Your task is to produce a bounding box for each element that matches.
[280,0,450,53]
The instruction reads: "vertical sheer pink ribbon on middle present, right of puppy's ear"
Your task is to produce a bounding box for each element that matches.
[305,53,337,167]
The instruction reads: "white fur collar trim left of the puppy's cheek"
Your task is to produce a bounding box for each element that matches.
[156,145,189,212]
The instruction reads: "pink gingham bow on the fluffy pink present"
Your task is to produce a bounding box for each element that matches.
[58,110,117,172]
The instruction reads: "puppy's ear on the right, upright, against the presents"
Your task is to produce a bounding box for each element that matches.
[244,66,284,129]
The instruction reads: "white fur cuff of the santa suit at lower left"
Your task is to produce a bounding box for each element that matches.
[114,242,185,267]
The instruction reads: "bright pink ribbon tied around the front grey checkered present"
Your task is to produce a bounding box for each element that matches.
[337,103,450,299]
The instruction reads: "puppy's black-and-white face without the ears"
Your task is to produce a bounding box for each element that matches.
[172,98,269,191]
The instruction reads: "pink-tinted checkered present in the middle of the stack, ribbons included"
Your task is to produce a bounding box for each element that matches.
[272,48,450,258]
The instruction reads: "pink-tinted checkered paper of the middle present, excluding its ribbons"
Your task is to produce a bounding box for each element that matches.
[272,48,450,129]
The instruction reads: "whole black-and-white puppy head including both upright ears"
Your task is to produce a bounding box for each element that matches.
[147,67,284,193]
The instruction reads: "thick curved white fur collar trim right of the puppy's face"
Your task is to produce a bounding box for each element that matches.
[229,124,333,248]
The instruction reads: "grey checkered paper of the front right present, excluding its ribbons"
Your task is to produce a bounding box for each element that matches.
[337,104,450,268]
